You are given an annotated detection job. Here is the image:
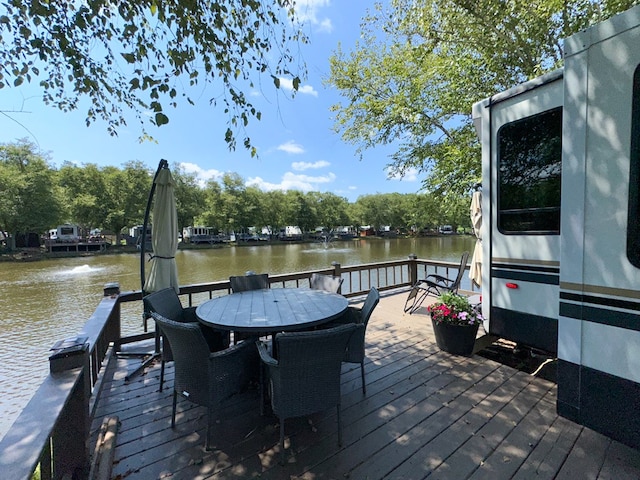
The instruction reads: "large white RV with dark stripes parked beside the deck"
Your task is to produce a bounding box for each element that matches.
[473,6,640,448]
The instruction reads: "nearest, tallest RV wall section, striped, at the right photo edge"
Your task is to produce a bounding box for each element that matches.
[558,3,640,448]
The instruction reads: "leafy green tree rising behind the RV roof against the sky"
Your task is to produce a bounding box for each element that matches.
[328,0,638,196]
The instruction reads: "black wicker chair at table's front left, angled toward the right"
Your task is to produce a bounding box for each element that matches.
[151,312,260,450]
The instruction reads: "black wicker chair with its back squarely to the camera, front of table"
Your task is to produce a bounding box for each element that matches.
[257,324,358,463]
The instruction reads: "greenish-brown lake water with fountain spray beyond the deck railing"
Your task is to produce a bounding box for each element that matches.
[0,236,475,438]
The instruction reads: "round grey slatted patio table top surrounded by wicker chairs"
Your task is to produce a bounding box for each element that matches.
[196,288,348,332]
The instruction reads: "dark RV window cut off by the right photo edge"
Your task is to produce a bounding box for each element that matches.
[627,65,640,268]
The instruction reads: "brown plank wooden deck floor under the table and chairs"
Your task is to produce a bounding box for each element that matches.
[92,293,640,480]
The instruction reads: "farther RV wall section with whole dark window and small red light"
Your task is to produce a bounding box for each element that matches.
[473,71,563,352]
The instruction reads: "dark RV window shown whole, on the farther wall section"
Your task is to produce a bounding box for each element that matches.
[498,107,562,235]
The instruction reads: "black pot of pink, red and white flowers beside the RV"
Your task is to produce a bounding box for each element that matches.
[427,292,482,356]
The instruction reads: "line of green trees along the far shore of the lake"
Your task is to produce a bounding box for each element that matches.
[0,139,470,244]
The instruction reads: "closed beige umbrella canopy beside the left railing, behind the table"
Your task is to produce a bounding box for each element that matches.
[144,168,179,293]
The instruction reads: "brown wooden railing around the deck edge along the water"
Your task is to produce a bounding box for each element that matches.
[0,255,472,480]
